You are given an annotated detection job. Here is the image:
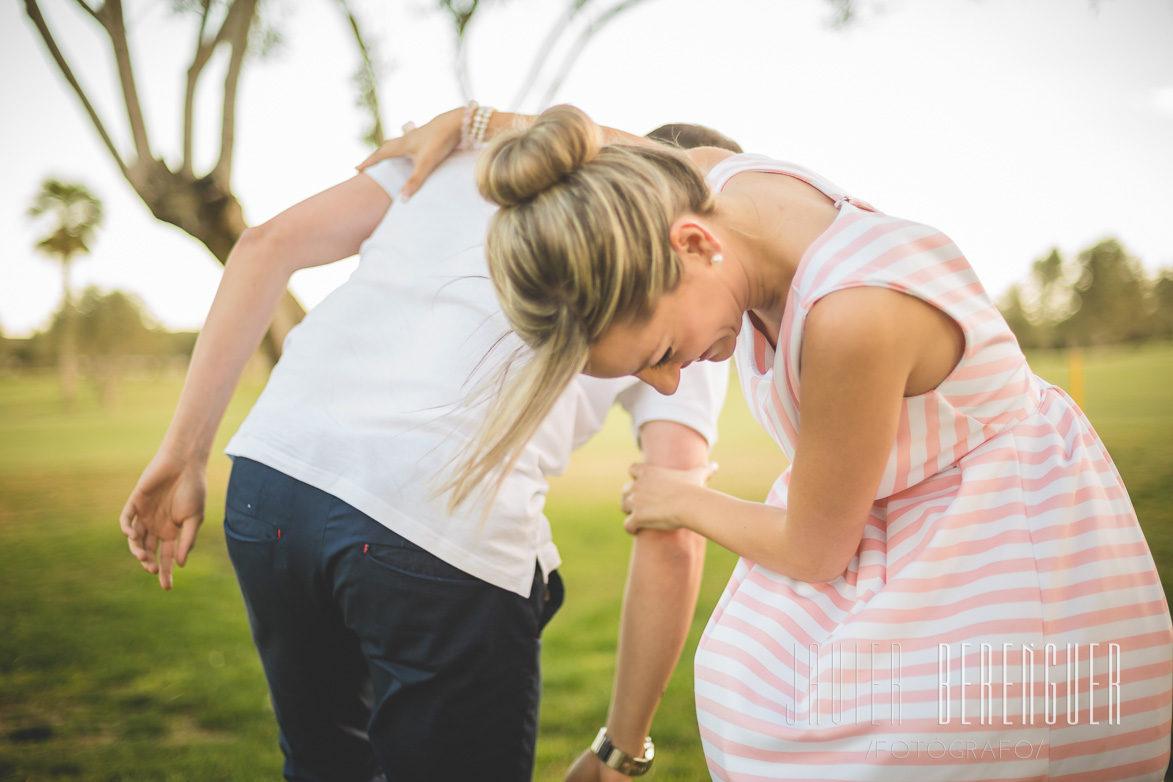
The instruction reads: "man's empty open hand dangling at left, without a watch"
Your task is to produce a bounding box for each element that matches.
[118,449,208,590]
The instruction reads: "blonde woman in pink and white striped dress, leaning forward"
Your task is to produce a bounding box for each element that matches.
[441,107,1173,782]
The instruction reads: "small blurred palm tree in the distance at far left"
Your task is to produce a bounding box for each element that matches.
[28,177,102,407]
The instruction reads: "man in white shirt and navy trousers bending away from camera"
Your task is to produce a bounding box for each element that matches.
[121,133,727,780]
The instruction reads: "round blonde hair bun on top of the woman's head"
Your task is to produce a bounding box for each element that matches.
[476,106,602,206]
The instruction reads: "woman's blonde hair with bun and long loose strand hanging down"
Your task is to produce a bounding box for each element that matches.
[446,106,714,508]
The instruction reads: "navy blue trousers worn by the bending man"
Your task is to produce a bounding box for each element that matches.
[224,457,562,782]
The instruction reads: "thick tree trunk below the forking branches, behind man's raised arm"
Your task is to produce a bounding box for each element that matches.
[128,161,305,362]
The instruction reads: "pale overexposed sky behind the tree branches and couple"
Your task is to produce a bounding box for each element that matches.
[0,0,1173,336]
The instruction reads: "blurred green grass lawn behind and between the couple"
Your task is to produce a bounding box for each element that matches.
[0,344,1173,781]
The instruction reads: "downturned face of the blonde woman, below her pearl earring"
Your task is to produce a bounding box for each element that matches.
[585,266,741,394]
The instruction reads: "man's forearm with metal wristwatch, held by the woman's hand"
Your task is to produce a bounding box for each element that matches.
[567,421,708,782]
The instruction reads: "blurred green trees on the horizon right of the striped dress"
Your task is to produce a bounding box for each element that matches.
[998,239,1173,348]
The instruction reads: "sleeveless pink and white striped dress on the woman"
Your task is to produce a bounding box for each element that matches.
[696,155,1173,782]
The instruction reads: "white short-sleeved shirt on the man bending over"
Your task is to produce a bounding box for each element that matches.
[225,155,728,596]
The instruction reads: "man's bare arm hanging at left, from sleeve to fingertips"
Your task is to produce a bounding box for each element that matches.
[118,175,391,590]
